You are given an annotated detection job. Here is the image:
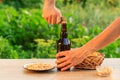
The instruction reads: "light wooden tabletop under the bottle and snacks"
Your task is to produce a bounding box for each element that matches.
[0,58,120,80]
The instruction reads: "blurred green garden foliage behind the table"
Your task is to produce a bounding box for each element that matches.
[0,0,120,59]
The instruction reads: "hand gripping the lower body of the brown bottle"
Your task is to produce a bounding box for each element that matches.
[56,48,88,71]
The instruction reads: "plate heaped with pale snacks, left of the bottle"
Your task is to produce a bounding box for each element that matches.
[23,63,55,71]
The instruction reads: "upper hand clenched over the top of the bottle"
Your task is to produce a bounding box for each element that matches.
[42,6,62,24]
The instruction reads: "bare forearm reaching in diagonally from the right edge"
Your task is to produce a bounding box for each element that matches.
[84,18,120,52]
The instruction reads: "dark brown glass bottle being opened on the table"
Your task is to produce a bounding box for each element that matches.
[57,21,71,70]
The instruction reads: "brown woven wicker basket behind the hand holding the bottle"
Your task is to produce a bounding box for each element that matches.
[75,52,104,69]
